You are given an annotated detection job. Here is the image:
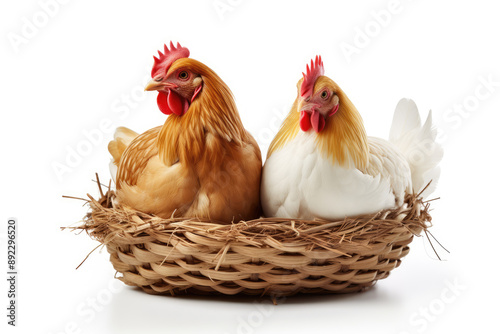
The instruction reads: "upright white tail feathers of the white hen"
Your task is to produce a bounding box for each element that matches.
[389,99,443,198]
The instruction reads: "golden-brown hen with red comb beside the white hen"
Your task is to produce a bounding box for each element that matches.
[108,43,262,223]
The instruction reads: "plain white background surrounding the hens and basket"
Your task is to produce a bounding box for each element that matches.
[0,0,500,334]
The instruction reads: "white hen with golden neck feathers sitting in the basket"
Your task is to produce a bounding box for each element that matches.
[261,57,443,220]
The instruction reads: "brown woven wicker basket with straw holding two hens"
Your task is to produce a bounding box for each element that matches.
[77,185,431,296]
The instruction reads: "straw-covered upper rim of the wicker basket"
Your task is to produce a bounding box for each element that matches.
[73,184,432,251]
